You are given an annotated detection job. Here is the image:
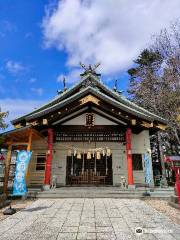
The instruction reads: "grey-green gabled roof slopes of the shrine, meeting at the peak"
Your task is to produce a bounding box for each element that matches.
[12,73,166,124]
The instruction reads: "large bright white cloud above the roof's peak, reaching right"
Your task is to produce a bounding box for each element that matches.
[42,0,180,75]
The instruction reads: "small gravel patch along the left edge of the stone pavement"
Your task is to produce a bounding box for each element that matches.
[0,200,33,221]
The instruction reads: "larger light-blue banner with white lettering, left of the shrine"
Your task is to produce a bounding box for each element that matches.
[13,150,32,196]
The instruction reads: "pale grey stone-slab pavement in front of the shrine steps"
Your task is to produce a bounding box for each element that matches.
[0,198,180,240]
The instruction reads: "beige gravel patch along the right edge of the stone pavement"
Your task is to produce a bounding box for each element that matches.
[145,199,180,225]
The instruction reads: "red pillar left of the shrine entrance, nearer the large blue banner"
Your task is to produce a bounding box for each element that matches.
[44,128,53,185]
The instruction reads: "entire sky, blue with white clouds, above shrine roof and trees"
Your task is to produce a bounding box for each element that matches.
[0,0,180,129]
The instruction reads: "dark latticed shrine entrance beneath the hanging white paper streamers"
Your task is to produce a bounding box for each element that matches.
[66,154,113,185]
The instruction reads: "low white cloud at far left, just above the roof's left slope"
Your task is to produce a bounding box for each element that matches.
[0,98,44,128]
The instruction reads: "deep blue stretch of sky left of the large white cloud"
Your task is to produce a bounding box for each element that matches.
[0,0,66,99]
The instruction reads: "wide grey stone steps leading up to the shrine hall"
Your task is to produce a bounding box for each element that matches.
[28,186,174,199]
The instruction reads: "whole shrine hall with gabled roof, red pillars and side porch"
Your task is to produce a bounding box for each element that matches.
[3,65,166,189]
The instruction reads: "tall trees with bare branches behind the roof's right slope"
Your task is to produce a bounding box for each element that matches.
[128,21,180,148]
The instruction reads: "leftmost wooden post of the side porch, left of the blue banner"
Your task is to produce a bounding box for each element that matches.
[3,144,12,196]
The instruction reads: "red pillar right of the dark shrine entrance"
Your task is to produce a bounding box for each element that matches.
[126,128,134,185]
